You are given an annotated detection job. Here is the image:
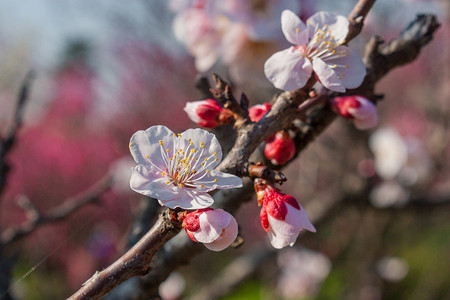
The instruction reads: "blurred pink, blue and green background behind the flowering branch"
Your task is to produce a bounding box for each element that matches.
[0,0,450,300]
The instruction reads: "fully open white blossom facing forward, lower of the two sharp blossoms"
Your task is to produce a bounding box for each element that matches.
[130,125,242,209]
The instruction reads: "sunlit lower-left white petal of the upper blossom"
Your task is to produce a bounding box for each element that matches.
[264,47,312,91]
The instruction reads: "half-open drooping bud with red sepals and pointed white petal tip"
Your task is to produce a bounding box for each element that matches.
[260,186,316,249]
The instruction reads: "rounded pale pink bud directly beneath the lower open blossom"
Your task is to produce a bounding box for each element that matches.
[183,208,238,251]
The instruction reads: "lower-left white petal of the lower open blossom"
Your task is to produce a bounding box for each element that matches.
[130,165,177,200]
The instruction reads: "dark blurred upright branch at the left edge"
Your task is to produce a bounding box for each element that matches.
[0,71,35,195]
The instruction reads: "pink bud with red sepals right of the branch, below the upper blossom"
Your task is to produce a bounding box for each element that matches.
[332,96,378,130]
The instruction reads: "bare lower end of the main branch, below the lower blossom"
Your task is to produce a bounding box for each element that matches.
[68,209,181,300]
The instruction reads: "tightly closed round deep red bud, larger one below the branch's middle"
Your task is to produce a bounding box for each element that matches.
[264,131,295,165]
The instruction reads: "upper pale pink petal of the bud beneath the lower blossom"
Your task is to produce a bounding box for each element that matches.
[193,209,233,243]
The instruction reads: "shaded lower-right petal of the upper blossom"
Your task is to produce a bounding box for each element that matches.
[323,46,366,89]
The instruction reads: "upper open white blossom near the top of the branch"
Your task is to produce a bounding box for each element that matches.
[264,10,366,92]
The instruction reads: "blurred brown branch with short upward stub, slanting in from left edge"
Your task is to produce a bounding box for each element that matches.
[0,175,112,246]
